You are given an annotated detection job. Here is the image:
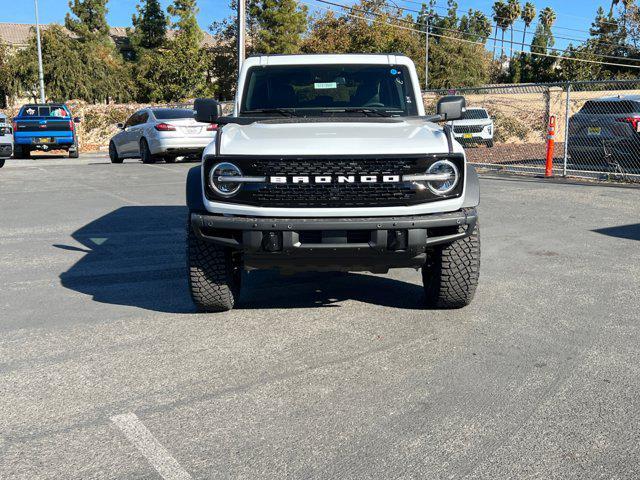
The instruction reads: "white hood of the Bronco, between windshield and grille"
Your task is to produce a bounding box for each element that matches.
[220,118,458,156]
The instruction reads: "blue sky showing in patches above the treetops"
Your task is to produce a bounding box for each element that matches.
[0,0,610,48]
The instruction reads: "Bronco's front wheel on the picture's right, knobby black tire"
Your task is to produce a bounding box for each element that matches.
[422,224,480,308]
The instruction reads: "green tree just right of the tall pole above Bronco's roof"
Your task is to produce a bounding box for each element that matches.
[249,0,307,54]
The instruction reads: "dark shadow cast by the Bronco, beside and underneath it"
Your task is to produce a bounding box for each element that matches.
[60,206,424,313]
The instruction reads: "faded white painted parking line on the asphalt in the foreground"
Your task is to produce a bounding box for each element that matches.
[111,413,193,480]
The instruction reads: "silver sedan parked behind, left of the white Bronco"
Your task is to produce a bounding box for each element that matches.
[109,108,217,163]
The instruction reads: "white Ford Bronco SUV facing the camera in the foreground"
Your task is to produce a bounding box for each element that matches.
[187,54,480,312]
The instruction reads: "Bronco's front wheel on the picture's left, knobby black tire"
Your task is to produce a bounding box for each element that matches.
[187,223,242,312]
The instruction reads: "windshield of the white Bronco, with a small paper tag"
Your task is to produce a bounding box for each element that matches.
[240,65,417,116]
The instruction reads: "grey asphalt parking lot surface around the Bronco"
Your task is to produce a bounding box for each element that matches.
[0,155,640,479]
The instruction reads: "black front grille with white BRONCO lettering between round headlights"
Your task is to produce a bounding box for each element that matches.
[205,155,464,208]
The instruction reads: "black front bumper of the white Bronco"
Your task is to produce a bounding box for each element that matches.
[191,208,478,272]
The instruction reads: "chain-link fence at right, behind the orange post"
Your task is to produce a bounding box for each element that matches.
[424,80,640,182]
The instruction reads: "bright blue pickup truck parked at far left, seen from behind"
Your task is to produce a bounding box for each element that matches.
[13,103,80,158]
